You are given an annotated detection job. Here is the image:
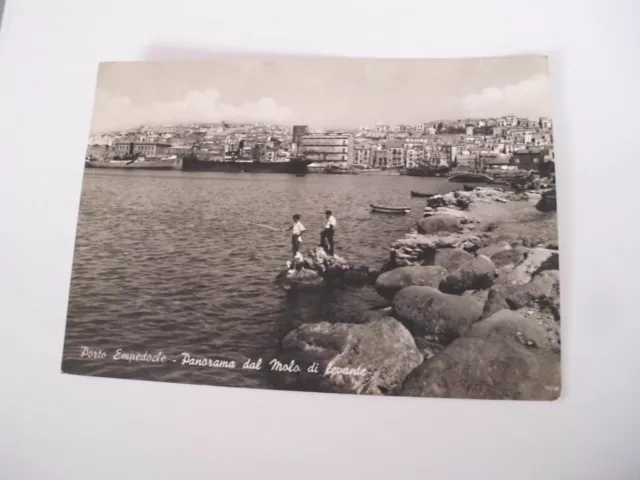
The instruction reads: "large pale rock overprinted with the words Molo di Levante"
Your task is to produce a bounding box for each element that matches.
[274,317,423,395]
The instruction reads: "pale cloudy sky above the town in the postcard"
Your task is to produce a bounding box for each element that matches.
[91,55,550,133]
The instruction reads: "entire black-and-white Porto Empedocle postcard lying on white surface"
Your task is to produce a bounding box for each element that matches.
[62,55,562,401]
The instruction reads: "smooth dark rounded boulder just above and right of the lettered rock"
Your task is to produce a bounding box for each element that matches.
[393,286,482,345]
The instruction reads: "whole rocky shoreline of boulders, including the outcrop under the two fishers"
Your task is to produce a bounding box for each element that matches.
[277,187,561,400]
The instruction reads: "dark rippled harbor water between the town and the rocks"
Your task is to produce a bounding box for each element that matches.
[63,171,459,388]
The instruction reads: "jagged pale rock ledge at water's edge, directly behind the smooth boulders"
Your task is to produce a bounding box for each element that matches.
[390,233,482,267]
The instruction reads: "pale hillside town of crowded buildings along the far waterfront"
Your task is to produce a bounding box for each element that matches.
[87,115,555,175]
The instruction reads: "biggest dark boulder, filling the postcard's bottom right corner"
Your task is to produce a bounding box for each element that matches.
[399,312,561,400]
